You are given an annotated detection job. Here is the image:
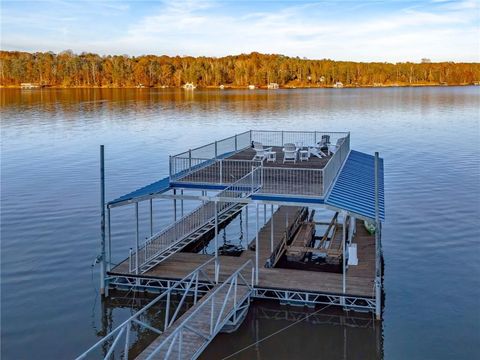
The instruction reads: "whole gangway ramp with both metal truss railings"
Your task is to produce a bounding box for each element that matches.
[76,258,255,360]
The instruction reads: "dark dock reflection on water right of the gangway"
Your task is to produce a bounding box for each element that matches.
[200,300,383,359]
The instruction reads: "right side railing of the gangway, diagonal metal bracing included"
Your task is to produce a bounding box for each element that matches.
[143,260,255,360]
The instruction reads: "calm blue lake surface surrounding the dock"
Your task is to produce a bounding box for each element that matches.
[0,87,480,359]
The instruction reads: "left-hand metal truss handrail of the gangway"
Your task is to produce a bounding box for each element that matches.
[76,258,215,360]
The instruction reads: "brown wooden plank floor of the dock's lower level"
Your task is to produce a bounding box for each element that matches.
[112,206,375,297]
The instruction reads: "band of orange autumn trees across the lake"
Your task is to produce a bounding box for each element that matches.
[0,50,480,87]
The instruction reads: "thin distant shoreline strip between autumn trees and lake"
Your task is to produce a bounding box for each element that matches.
[0,83,479,91]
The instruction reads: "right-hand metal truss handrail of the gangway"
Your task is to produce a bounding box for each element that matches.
[147,259,255,360]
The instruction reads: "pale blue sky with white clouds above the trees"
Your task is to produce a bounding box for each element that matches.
[0,0,480,62]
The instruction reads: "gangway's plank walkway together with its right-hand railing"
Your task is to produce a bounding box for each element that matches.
[137,260,255,360]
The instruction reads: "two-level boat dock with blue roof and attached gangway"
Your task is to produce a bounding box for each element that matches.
[80,130,384,359]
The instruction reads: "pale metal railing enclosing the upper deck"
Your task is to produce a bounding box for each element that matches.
[170,130,350,197]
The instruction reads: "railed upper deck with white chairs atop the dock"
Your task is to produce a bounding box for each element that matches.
[170,130,350,198]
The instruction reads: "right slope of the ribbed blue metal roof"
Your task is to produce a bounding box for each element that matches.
[325,150,385,221]
